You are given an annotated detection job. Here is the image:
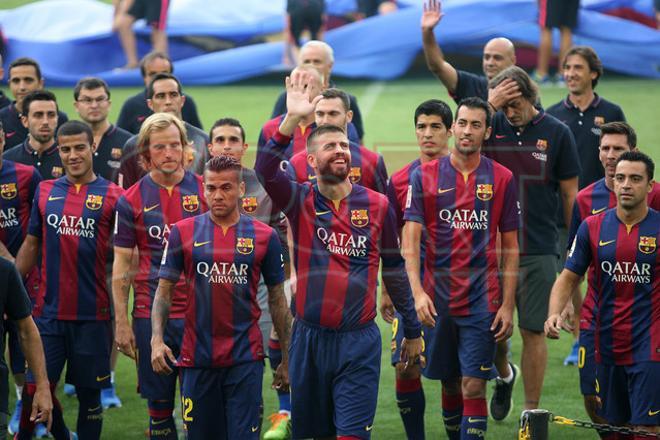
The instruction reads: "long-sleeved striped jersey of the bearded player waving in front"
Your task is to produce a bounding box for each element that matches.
[255,131,421,338]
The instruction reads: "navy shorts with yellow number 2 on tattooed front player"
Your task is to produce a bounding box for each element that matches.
[180,361,264,440]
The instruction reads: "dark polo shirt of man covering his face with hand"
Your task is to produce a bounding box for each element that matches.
[484,110,580,255]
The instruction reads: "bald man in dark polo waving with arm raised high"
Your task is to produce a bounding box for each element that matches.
[421,0,520,111]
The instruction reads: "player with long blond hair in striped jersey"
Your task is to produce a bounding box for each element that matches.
[112,113,207,439]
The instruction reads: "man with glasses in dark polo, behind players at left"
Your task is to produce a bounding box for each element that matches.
[73,77,131,183]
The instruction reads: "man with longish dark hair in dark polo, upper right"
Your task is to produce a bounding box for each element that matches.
[546,46,626,365]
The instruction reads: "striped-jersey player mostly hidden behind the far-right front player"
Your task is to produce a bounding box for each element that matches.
[565,122,660,434]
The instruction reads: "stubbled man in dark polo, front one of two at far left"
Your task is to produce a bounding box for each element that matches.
[2,90,64,180]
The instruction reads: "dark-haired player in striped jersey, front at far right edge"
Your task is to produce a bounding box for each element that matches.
[545,151,660,439]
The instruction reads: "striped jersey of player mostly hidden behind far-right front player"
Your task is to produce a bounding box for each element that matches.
[568,178,660,330]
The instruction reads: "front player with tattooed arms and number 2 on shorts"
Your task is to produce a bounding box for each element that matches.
[151,156,291,440]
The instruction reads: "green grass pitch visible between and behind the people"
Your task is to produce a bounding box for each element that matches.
[3,75,660,440]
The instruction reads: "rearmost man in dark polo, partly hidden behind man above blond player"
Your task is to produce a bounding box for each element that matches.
[117,52,202,134]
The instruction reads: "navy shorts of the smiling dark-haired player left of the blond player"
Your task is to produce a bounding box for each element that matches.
[27,318,112,389]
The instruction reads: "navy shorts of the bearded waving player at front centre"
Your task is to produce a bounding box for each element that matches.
[289,320,382,439]
